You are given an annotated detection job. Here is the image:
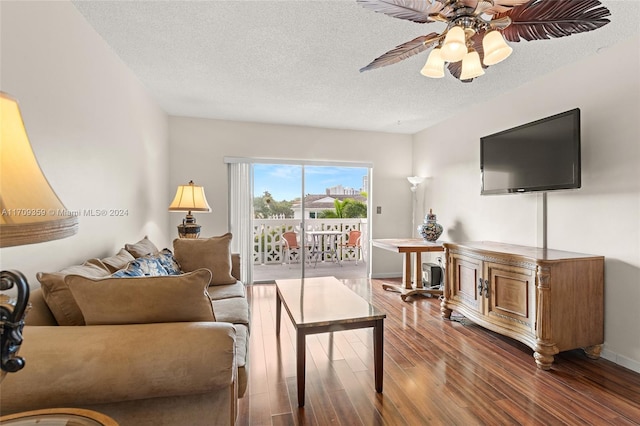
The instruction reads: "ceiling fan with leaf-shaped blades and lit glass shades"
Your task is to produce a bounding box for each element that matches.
[356,0,611,82]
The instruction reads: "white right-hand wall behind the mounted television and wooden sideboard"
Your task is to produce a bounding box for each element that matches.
[413,37,640,371]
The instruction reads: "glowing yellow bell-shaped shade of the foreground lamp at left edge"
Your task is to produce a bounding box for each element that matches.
[0,92,78,247]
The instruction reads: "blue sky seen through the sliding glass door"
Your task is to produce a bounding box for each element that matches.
[253,164,367,201]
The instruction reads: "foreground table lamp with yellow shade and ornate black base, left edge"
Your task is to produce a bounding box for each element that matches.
[0,92,78,381]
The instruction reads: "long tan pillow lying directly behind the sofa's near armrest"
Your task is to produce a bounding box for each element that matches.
[65,269,215,325]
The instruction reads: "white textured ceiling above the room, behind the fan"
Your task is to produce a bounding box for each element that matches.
[74,0,640,133]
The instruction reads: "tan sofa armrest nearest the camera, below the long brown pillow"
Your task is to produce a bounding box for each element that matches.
[0,322,237,413]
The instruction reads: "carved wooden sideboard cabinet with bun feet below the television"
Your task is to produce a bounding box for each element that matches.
[440,242,604,370]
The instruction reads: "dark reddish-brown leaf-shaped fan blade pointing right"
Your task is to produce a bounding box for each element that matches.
[495,0,611,42]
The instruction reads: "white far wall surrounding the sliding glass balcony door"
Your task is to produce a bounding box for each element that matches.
[169,117,412,276]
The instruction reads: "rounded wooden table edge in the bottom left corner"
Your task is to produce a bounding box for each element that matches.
[0,408,118,426]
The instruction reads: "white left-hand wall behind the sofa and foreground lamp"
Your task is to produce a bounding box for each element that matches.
[0,1,171,287]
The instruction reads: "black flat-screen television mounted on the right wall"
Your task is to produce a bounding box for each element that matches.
[480,108,581,195]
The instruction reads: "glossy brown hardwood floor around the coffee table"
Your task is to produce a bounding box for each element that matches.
[238,280,640,426]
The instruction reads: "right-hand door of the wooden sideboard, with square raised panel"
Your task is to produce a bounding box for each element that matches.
[484,263,535,332]
